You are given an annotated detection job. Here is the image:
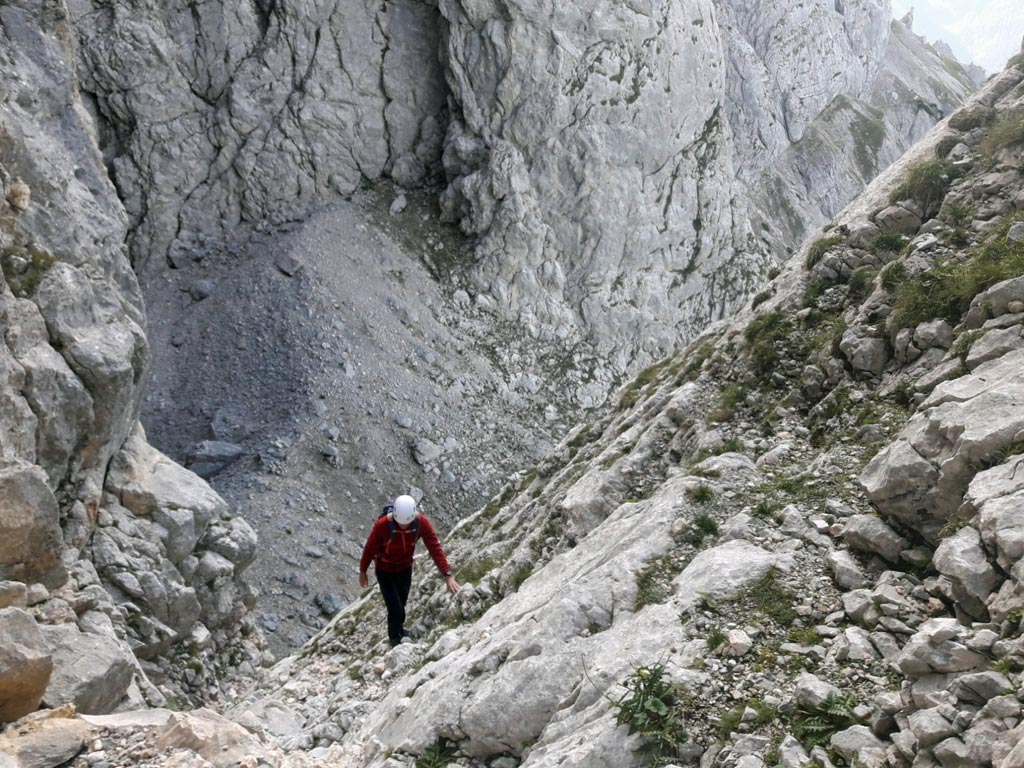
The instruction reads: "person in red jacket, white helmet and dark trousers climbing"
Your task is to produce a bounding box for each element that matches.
[359,496,459,646]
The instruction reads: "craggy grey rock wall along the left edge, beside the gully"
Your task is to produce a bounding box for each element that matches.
[0,0,258,711]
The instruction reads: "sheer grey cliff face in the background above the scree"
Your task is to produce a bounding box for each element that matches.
[72,0,973,371]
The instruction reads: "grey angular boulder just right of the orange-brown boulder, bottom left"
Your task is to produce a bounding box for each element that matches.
[40,624,135,715]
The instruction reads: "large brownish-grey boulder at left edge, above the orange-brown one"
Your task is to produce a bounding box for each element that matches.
[0,462,67,588]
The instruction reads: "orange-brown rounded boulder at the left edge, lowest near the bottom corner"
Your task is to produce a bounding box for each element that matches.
[0,608,53,723]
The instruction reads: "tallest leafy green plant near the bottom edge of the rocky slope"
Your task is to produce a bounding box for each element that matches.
[614,664,687,768]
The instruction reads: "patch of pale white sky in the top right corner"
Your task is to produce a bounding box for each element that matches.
[893,0,1024,74]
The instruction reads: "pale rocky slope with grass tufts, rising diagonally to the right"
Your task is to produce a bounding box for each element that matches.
[18,57,1024,768]
